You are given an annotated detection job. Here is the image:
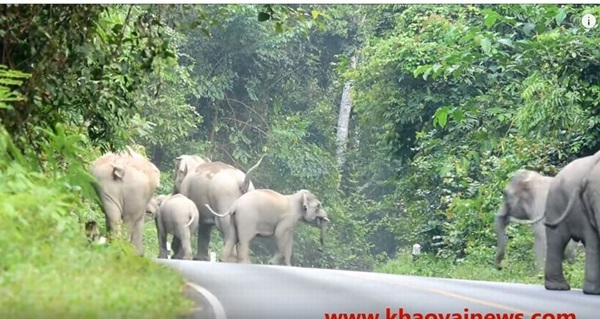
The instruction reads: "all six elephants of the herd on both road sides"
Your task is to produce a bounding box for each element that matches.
[86,148,600,295]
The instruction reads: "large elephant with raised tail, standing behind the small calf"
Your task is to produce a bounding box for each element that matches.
[173,155,265,262]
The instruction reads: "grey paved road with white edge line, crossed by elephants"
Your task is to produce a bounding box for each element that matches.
[157,260,600,319]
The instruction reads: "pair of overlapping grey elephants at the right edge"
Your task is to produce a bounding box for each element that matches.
[495,151,600,295]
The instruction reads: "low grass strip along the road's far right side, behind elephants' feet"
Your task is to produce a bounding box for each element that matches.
[375,251,584,288]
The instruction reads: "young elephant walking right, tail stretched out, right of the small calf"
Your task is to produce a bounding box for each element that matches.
[206,189,330,266]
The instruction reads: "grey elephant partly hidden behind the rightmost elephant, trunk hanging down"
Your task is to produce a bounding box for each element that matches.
[494,169,577,273]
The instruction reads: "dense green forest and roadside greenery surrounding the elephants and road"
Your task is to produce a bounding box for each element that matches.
[0,4,600,318]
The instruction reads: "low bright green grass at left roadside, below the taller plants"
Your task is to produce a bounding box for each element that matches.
[0,243,192,319]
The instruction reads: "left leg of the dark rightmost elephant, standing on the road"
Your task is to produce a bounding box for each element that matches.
[544,225,571,290]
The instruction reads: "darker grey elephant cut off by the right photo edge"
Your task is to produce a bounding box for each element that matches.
[544,152,600,295]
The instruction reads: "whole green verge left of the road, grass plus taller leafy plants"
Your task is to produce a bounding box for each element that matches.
[0,131,192,319]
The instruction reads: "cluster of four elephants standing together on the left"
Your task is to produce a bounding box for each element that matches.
[86,148,329,266]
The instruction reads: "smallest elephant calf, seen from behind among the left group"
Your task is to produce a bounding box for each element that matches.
[149,194,200,260]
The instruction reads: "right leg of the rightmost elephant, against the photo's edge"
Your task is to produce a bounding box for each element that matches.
[583,230,600,295]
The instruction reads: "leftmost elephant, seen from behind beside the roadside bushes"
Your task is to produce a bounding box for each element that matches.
[91,147,160,256]
